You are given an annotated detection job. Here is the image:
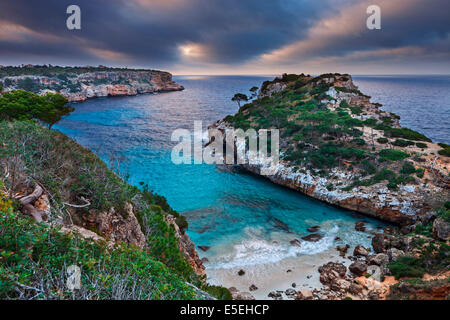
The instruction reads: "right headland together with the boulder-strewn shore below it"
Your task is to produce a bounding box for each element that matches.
[210,74,450,300]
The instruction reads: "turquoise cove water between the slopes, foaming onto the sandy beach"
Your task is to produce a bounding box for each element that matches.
[56,76,448,268]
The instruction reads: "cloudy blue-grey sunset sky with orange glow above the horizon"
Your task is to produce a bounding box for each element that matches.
[0,0,450,75]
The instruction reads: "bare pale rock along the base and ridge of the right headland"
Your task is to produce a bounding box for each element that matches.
[209,75,450,225]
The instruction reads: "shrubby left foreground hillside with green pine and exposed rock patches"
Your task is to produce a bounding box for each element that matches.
[0,90,224,299]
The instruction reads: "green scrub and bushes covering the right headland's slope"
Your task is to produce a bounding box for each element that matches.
[225,74,440,190]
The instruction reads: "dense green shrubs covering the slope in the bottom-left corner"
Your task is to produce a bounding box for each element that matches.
[0,212,200,300]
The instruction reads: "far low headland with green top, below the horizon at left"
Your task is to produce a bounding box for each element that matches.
[0,66,184,102]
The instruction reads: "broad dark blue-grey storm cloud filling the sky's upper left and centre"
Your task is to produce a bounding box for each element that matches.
[0,0,326,64]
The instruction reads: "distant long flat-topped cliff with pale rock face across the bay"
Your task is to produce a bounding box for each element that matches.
[0,70,184,102]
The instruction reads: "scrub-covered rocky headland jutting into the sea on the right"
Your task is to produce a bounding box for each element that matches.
[210,74,450,226]
